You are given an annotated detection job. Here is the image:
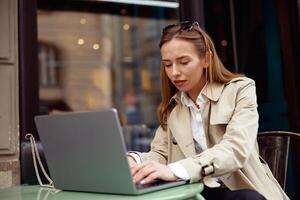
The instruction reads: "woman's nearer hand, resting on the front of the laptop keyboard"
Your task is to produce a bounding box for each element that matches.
[131,161,178,184]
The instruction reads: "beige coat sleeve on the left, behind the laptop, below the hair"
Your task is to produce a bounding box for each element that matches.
[138,127,168,164]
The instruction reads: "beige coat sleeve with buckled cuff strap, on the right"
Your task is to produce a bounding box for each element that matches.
[179,80,258,182]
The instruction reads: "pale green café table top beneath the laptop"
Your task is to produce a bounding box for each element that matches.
[0,183,205,200]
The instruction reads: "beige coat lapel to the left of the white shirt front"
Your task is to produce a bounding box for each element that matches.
[168,105,196,157]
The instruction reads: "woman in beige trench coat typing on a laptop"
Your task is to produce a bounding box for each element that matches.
[128,22,288,200]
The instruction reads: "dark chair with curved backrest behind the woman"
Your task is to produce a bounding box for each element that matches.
[257,131,300,189]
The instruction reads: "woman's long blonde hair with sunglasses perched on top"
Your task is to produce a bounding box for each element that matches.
[157,23,242,130]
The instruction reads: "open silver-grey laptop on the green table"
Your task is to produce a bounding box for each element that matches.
[35,109,185,194]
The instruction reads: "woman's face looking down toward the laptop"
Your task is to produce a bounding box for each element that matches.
[161,38,208,101]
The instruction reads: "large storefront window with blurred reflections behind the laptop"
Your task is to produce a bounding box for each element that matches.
[38,2,177,130]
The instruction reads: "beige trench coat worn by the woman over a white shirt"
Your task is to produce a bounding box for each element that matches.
[140,77,289,200]
